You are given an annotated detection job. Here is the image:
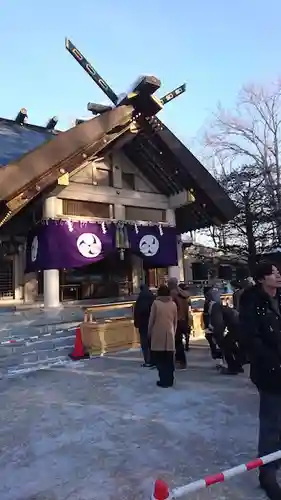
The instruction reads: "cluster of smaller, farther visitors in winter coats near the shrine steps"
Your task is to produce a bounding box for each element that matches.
[134,278,244,387]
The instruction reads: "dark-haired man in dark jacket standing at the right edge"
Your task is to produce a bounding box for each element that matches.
[240,263,281,500]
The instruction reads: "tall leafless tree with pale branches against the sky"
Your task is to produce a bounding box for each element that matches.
[206,81,281,246]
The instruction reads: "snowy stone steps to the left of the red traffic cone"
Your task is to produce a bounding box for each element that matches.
[0,300,135,378]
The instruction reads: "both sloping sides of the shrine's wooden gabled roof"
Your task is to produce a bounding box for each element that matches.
[0,108,237,232]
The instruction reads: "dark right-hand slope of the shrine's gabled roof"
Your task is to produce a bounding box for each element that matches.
[124,117,237,232]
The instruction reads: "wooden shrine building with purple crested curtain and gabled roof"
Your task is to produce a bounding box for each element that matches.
[0,39,237,308]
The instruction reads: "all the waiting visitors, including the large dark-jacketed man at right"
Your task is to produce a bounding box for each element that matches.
[134,263,281,500]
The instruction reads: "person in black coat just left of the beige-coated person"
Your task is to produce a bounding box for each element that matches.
[134,285,155,367]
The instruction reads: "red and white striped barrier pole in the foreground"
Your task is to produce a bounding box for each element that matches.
[152,450,281,500]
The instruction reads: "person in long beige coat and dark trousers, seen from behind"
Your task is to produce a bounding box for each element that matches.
[148,285,178,387]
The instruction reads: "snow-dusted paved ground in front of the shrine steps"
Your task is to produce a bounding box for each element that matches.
[0,347,272,500]
